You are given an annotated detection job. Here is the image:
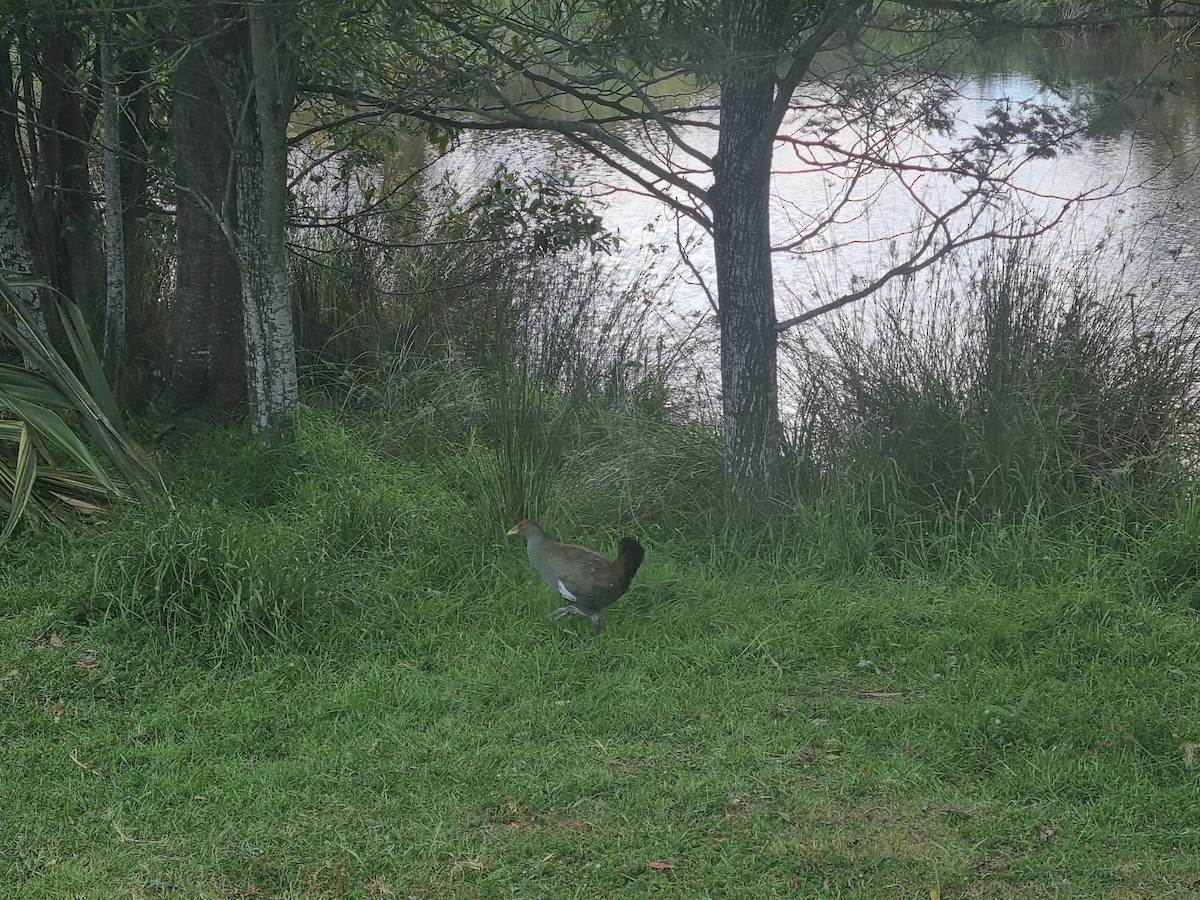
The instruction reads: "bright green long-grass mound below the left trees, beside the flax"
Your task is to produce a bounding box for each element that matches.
[84,410,482,659]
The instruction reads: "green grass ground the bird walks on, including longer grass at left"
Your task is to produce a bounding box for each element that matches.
[0,422,1200,898]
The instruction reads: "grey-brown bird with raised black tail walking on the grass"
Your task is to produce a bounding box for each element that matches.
[509,518,646,637]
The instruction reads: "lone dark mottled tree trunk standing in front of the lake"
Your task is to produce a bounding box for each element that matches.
[709,0,786,509]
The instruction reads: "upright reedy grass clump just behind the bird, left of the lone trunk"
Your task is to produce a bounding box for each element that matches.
[456,259,720,521]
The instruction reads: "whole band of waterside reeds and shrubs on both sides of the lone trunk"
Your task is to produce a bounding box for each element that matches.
[292,202,1200,574]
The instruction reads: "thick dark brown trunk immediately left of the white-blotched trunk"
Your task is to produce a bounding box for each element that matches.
[168,2,246,413]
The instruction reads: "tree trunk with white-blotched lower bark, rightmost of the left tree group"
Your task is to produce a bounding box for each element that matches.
[234,4,296,445]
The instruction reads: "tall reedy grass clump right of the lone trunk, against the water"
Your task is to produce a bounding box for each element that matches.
[790,245,1200,571]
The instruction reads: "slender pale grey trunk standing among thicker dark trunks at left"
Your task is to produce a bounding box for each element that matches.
[100,23,126,384]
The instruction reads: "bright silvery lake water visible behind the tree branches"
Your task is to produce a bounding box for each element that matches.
[434,35,1200,336]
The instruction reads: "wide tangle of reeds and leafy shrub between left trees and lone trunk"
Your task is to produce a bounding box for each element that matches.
[290,164,720,522]
